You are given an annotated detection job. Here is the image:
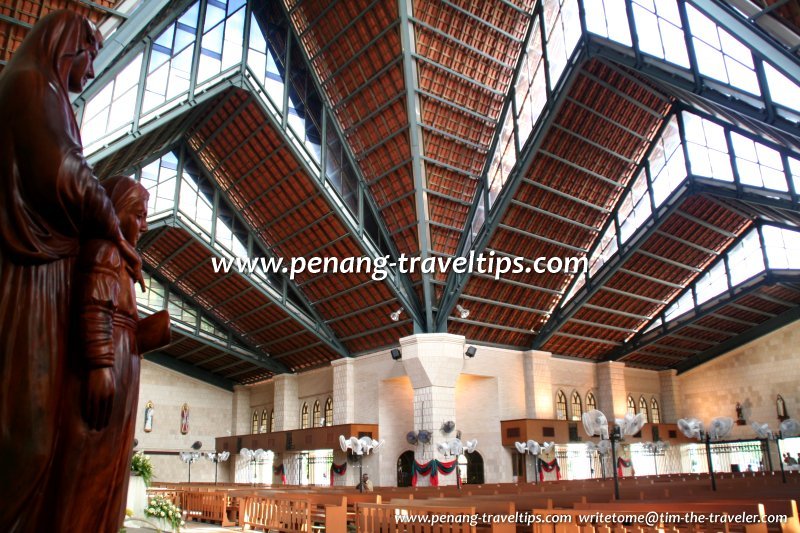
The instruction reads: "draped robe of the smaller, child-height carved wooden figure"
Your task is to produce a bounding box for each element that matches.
[48,240,140,533]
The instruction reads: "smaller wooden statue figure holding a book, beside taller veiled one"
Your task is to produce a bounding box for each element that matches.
[48,176,169,532]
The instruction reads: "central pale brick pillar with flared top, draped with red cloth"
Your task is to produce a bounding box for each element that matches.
[400,333,465,486]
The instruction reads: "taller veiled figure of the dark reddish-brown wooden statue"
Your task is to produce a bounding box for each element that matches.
[0,11,141,532]
